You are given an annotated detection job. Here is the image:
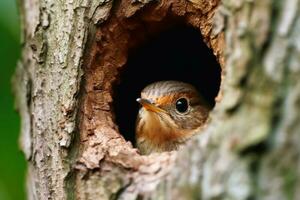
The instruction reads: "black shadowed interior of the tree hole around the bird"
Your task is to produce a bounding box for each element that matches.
[113,26,221,145]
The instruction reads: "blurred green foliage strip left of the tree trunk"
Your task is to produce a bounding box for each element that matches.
[0,0,25,200]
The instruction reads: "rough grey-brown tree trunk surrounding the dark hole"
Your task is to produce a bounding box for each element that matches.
[14,0,300,200]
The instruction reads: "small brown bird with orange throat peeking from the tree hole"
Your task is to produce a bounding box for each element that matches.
[135,80,211,155]
